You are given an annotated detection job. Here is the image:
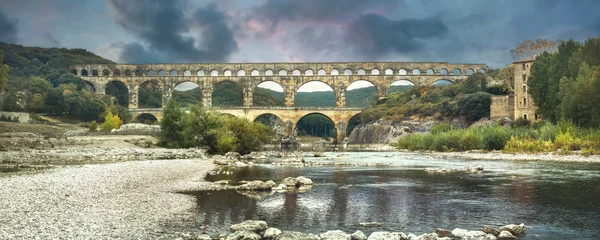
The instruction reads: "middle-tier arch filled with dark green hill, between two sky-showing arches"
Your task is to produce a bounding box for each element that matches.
[211,80,244,107]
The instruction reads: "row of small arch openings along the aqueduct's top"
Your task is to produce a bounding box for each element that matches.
[72,68,486,77]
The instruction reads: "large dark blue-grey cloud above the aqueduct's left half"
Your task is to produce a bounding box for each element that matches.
[109,0,237,63]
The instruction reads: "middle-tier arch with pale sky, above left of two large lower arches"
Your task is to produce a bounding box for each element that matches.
[252,80,286,106]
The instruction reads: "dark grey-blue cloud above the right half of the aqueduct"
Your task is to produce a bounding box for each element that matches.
[346,14,448,56]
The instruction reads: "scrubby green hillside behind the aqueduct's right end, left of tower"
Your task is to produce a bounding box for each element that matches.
[360,73,491,123]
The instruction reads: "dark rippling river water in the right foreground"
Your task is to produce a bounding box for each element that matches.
[188,152,600,239]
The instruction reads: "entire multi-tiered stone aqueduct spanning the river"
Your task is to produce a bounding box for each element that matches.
[70,62,489,142]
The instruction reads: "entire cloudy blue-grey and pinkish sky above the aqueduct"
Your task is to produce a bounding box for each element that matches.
[0,0,600,68]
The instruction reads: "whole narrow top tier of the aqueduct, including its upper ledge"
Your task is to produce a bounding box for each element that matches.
[70,62,489,77]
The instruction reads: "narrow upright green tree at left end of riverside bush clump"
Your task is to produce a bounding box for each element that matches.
[158,99,184,148]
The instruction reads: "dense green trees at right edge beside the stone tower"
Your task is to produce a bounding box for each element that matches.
[527,38,600,127]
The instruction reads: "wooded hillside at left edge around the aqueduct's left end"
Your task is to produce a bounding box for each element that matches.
[0,43,122,121]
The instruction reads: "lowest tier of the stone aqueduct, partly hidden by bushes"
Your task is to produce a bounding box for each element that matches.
[129,107,362,142]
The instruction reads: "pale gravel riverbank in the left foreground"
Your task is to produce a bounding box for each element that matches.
[0,159,214,239]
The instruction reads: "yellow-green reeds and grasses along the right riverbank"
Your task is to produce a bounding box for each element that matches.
[396,122,600,154]
